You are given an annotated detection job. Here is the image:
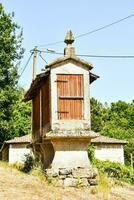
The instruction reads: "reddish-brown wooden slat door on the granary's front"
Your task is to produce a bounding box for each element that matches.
[57,74,84,119]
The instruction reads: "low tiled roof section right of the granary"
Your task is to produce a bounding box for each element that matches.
[91,135,128,144]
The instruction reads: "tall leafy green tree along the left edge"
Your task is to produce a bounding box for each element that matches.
[0,4,24,147]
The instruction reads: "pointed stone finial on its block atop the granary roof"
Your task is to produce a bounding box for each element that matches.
[64,30,75,56]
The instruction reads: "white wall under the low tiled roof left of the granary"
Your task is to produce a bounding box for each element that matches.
[9,144,30,163]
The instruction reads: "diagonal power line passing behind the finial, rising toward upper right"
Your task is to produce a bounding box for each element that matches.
[38,14,134,47]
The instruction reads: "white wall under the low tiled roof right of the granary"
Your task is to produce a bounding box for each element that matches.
[95,144,124,164]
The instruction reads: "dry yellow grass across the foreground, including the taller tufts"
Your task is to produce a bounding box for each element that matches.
[0,162,134,200]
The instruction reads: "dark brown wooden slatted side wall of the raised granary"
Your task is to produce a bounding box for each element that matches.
[32,77,50,139]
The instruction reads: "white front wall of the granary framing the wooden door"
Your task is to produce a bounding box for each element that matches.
[50,63,90,129]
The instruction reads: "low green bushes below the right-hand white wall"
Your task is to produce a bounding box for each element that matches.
[93,160,134,184]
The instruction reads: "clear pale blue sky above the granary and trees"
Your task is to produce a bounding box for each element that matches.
[1,0,134,103]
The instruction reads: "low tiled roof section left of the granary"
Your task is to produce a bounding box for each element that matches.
[5,134,32,144]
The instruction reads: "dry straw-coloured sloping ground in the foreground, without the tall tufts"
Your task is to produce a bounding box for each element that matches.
[0,164,134,200]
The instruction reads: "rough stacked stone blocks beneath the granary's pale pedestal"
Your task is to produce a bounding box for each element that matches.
[46,167,97,187]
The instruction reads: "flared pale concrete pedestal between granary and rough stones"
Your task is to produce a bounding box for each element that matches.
[51,138,90,169]
